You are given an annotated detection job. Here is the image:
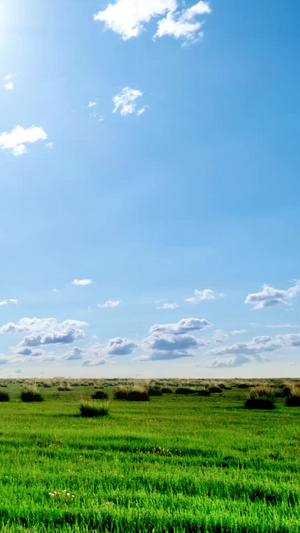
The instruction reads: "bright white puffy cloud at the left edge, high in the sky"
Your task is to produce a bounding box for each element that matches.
[0,126,47,156]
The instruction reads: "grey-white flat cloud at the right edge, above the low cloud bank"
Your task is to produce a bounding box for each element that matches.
[245,280,300,309]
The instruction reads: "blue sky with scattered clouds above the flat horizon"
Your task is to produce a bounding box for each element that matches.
[0,0,300,378]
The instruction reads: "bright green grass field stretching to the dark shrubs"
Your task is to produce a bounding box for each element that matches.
[0,380,300,533]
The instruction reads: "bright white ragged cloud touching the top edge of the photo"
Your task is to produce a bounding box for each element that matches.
[94,0,211,40]
